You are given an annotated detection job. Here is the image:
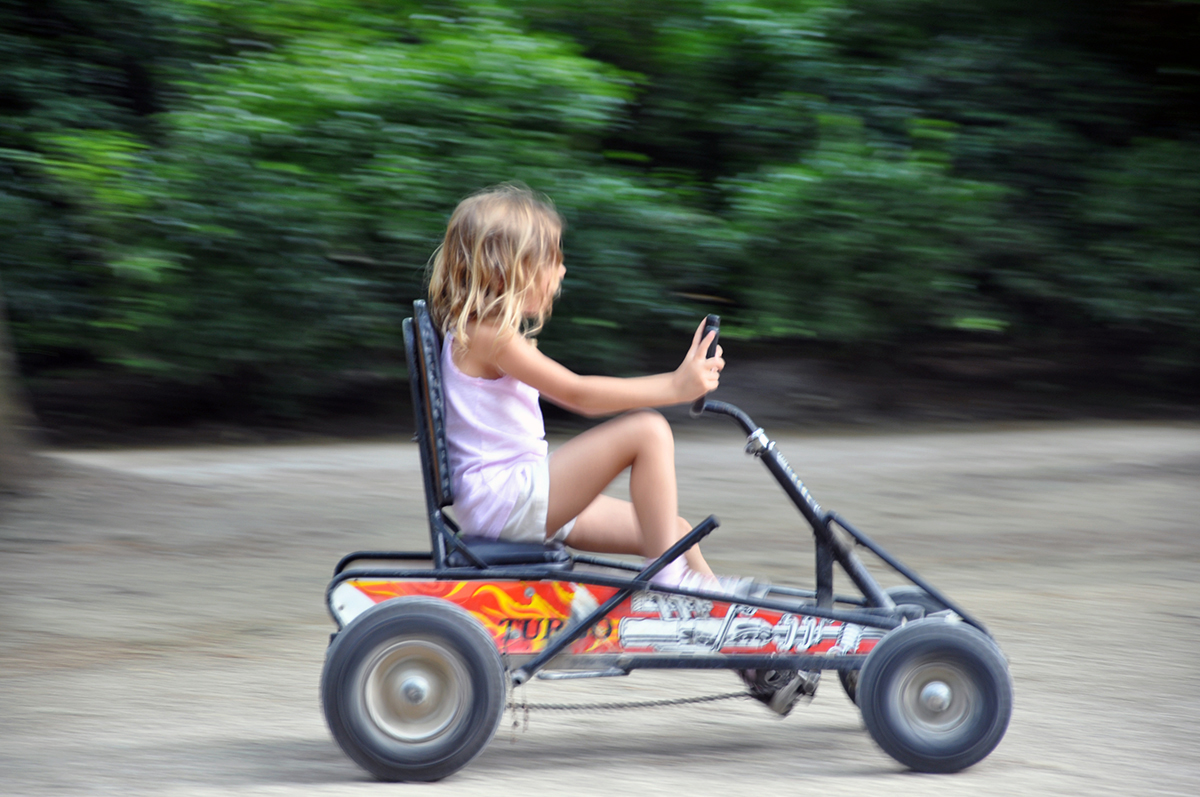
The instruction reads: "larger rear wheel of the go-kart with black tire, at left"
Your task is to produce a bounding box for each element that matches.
[320,598,505,780]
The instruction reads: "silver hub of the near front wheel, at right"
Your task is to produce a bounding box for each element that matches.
[894,661,980,742]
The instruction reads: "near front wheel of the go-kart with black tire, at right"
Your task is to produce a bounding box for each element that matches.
[858,617,1013,772]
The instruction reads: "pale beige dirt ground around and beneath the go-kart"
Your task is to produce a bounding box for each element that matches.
[0,421,1200,796]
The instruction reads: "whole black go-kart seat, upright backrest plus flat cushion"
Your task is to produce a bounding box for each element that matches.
[403,299,574,570]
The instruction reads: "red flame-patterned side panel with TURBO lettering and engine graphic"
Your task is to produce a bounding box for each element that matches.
[331,580,882,654]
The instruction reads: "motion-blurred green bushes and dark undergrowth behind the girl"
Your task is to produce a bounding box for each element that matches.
[0,0,1200,441]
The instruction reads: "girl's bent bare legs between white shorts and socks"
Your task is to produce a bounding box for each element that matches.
[546,411,712,574]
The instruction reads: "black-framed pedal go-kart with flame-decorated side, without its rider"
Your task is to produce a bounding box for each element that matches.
[322,301,1013,780]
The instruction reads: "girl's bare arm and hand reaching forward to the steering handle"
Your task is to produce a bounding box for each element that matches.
[482,322,725,415]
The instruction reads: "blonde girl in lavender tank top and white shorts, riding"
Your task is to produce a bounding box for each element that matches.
[430,185,751,595]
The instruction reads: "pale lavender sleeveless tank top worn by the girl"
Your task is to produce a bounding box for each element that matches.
[442,335,547,539]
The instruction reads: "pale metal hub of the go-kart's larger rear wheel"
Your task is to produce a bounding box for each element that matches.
[362,640,470,743]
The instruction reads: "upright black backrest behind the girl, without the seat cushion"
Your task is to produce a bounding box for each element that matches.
[403,299,454,514]
